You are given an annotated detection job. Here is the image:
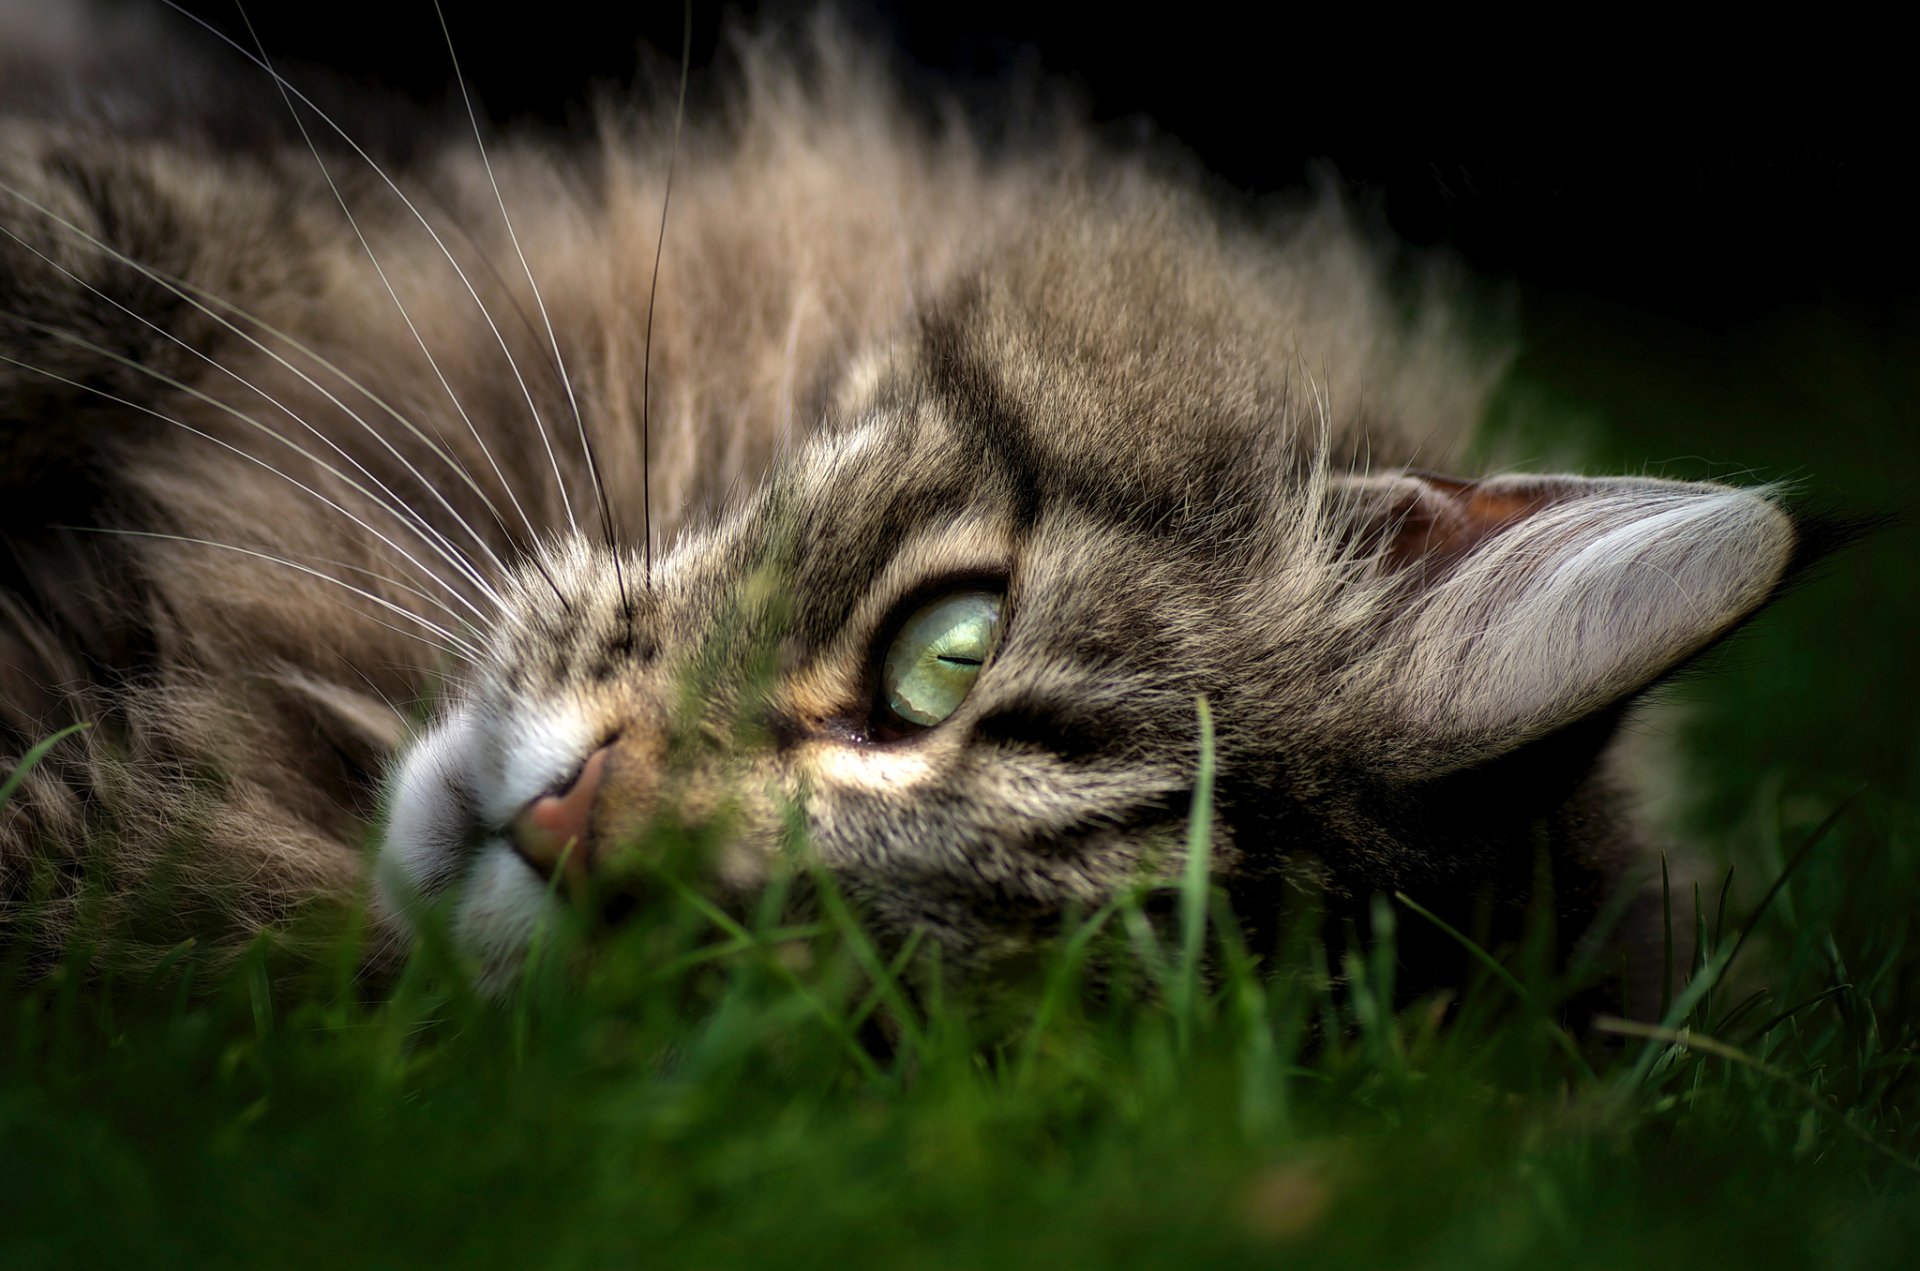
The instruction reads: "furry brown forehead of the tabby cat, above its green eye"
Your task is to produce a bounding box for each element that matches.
[664,213,1311,652]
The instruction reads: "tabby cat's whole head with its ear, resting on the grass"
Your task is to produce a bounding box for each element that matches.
[380,211,1795,975]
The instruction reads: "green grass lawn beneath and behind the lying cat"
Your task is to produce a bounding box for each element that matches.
[0,293,1920,1267]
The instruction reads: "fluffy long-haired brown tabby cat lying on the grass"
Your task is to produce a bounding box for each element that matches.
[0,6,1809,1006]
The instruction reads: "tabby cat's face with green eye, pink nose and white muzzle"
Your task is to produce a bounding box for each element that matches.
[382,324,1259,970]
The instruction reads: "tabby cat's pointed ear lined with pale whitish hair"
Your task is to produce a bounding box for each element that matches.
[1346,472,1795,772]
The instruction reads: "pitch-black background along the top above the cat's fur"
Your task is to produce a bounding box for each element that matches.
[142,0,1920,328]
